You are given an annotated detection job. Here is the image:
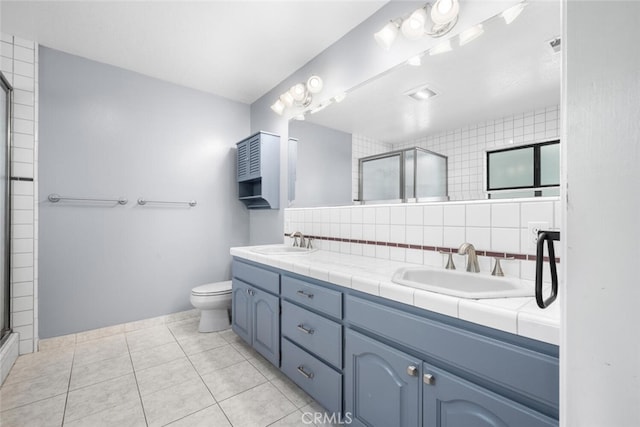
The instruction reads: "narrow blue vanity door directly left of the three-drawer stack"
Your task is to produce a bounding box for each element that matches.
[251,288,280,366]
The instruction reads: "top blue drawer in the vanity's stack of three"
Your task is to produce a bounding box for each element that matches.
[282,276,342,319]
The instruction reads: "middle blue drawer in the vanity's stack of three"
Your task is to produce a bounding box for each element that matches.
[280,301,342,369]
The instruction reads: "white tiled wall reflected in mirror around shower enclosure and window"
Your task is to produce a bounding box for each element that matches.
[352,105,560,200]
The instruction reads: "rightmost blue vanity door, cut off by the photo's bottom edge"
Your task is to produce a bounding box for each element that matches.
[422,363,558,427]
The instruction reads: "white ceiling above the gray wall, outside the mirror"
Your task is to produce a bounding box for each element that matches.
[0,0,387,103]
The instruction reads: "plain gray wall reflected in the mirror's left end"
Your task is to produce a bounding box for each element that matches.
[289,120,352,207]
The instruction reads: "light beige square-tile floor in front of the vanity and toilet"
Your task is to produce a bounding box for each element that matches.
[0,317,336,427]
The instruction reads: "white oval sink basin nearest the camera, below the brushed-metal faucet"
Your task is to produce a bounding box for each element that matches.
[391,267,535,299]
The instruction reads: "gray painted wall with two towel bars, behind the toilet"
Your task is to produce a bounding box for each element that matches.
[39,48,250,338]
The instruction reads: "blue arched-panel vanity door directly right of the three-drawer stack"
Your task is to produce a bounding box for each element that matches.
[344,330,421,427]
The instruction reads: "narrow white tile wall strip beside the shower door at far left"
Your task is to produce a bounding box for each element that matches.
[0,34,38,354]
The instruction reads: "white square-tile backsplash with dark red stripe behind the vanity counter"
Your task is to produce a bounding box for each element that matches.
[284,197,562,280]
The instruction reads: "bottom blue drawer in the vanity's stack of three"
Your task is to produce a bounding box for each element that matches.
[281,338,342,413]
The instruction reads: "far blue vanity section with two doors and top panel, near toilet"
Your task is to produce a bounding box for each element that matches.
[231,261,280,366]
